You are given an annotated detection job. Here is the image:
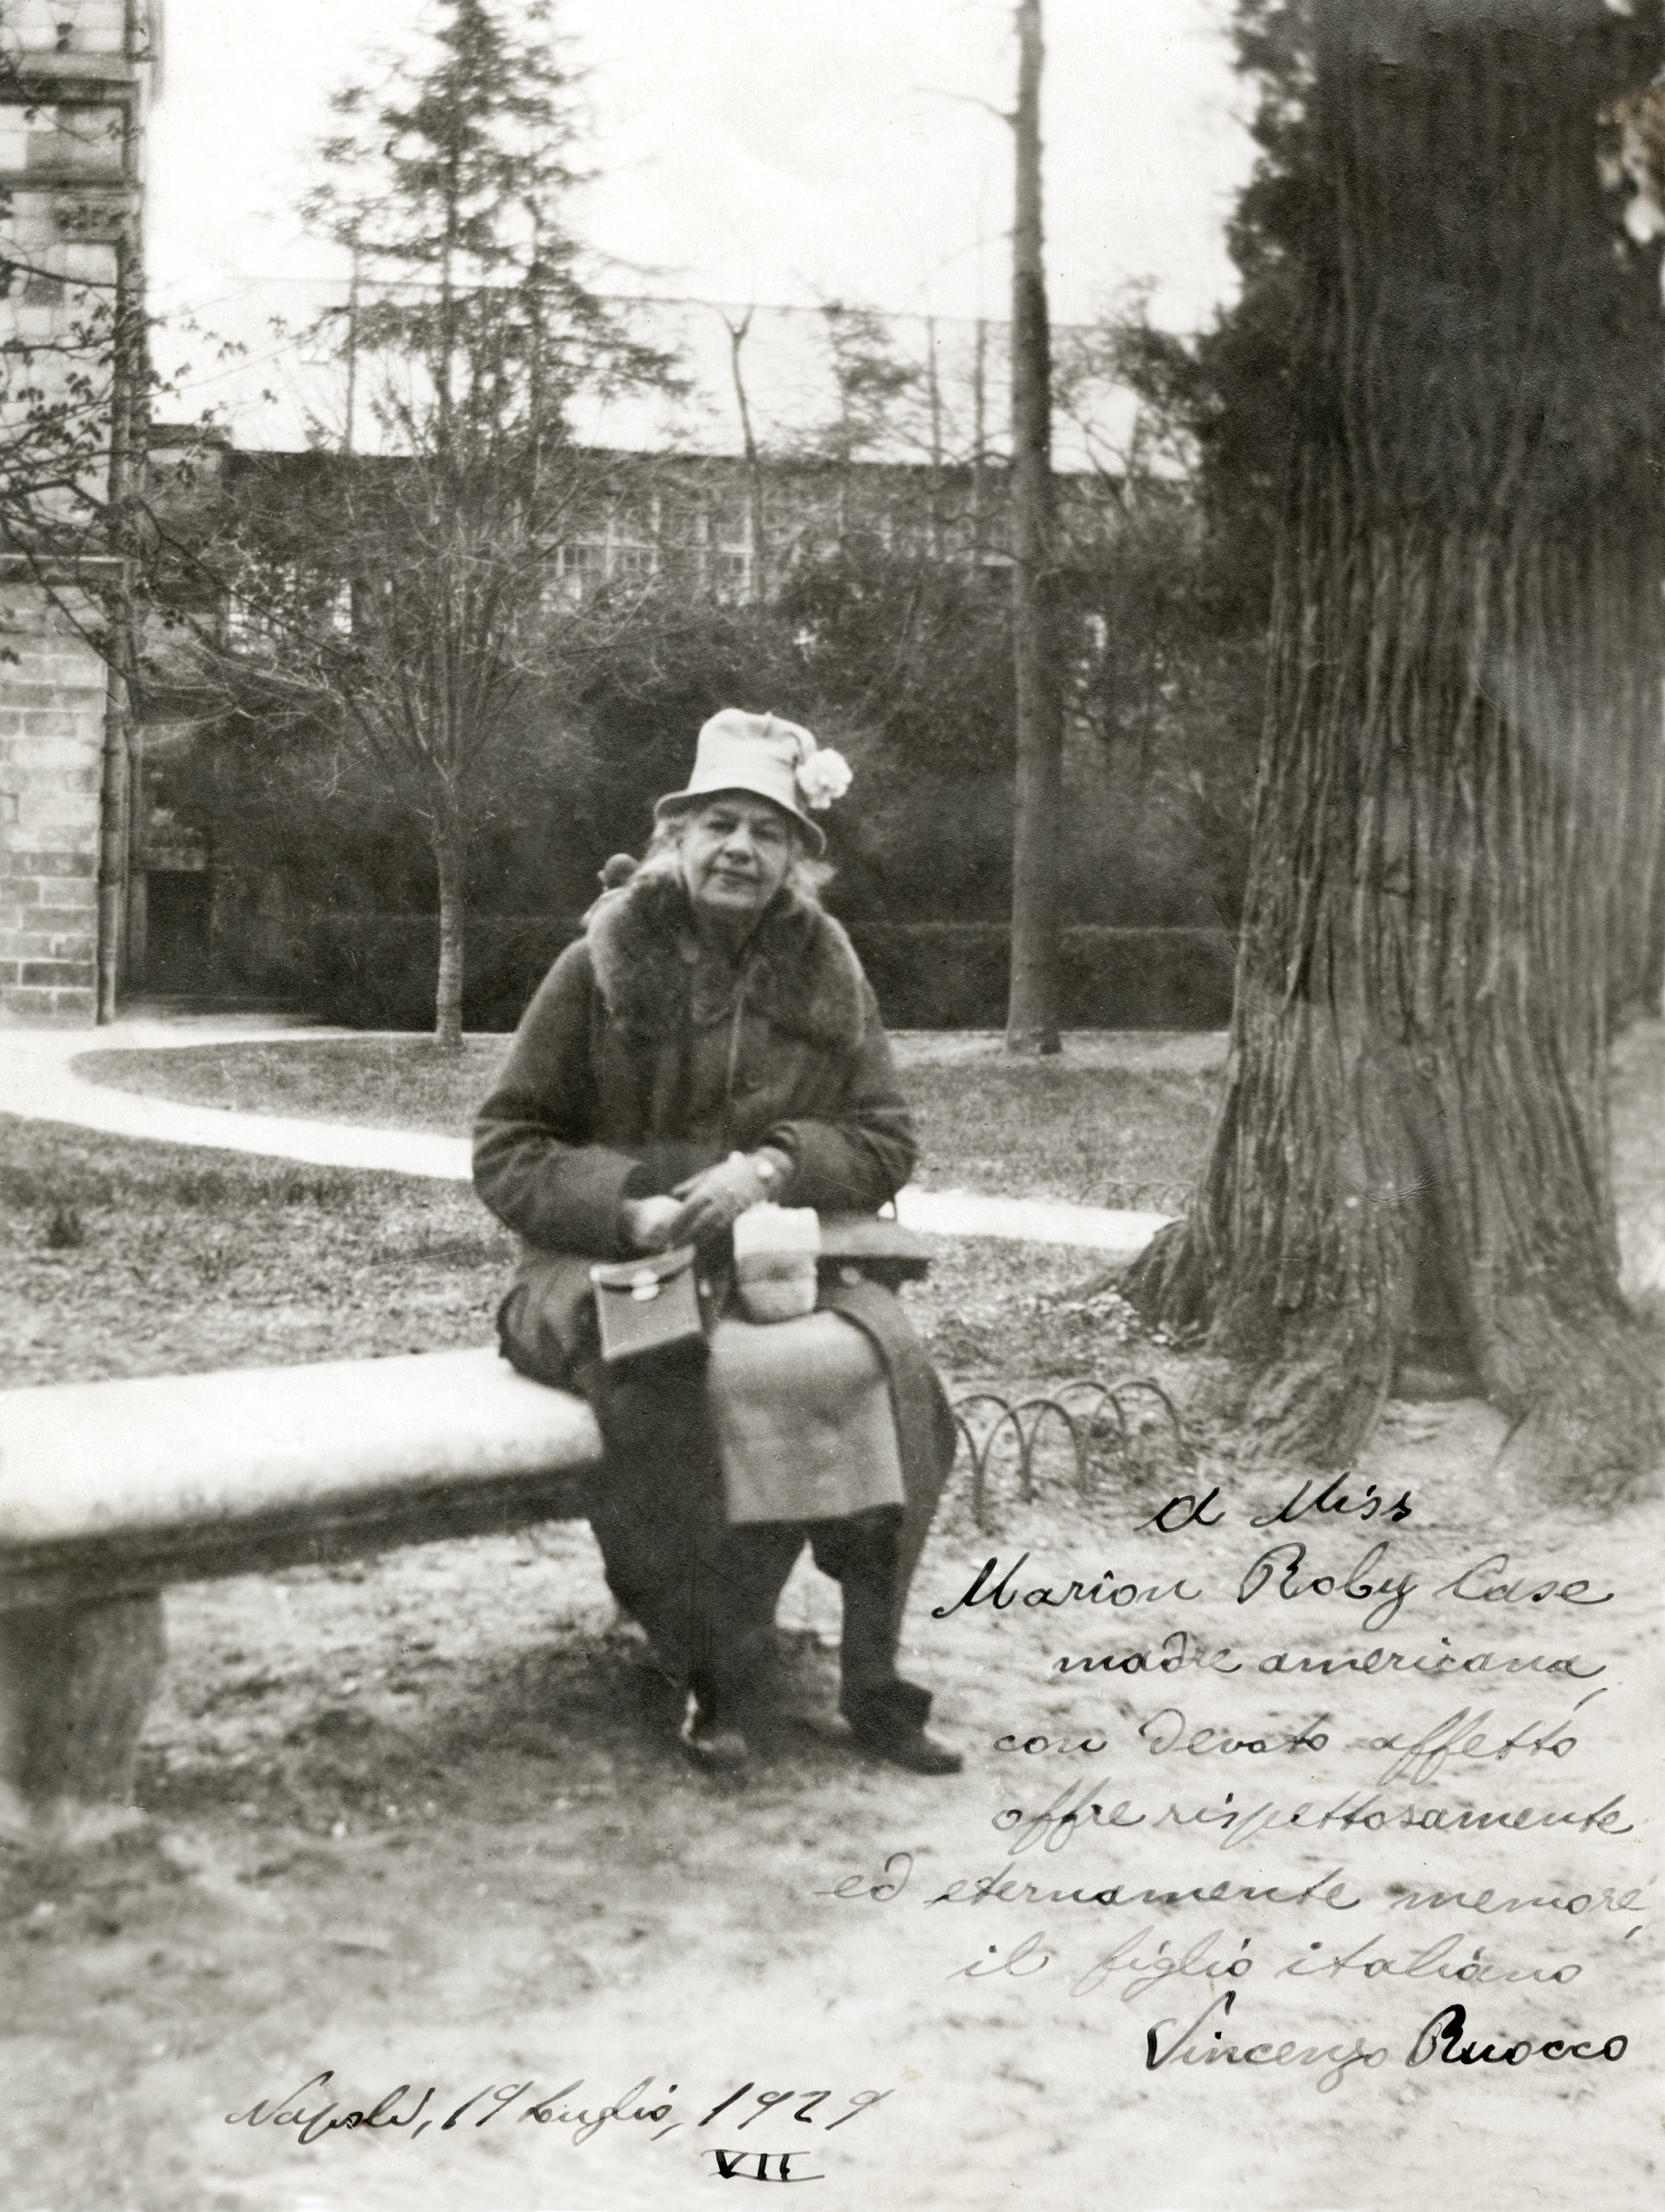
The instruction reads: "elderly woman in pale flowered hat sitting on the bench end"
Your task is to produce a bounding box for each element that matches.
[473,708,960,1774]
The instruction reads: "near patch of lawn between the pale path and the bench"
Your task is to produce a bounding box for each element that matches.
[0,1117,1185,1387]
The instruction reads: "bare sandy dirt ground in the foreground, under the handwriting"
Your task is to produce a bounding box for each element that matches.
[0,1030,1665,2212]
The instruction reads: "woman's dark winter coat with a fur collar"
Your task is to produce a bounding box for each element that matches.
[473,868,956,1643]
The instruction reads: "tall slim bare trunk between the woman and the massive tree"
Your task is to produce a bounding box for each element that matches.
[1006,0,1064,1053]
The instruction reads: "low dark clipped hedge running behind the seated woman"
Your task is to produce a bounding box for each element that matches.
[292,913,1234,1031]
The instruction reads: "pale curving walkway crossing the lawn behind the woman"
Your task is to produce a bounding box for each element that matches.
[0,1015,1167,1261]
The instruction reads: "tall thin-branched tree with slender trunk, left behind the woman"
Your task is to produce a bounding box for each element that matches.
[183,0,670,1046]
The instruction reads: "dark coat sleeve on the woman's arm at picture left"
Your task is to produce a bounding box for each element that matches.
[473,943,641,1259]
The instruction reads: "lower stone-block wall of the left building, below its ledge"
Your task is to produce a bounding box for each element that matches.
[0,584,106,1022]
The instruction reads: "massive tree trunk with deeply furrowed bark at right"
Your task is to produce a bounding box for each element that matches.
[1132,0,1665,1489]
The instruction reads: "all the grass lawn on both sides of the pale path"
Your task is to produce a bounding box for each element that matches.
[0,1035,1218,1385]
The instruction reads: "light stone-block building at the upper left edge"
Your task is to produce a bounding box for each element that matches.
[0,0,159,1022]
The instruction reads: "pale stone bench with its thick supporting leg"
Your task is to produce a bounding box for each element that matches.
[0,1347,601,1847]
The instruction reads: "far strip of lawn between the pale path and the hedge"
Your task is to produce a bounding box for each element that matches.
[78,1031,1223,1212]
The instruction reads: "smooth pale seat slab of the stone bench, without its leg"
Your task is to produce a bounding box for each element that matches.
[0,1350,601,1612]
